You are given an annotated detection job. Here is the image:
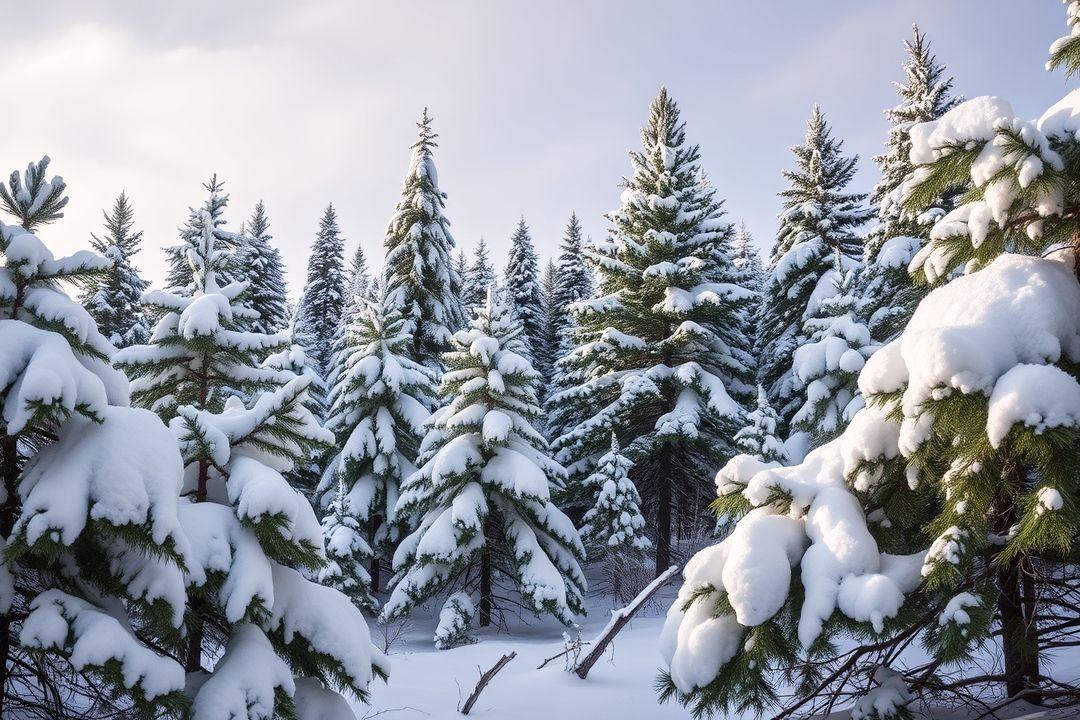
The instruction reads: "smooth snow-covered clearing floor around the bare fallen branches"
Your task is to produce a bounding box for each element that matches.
[356,587,689,720]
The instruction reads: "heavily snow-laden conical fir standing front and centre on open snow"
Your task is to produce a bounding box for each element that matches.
[382,289,586,626]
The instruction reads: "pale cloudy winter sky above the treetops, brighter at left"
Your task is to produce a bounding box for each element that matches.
[0,0,1075,296]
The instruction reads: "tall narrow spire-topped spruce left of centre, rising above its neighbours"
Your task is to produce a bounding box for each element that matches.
[383,108,465,367]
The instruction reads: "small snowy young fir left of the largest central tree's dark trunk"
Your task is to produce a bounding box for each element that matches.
[581,433,651,554]
